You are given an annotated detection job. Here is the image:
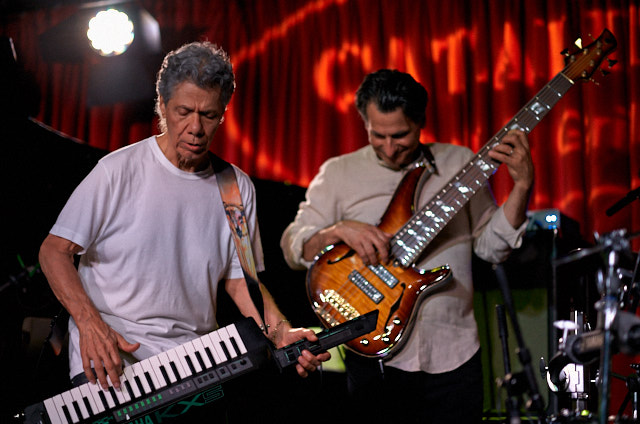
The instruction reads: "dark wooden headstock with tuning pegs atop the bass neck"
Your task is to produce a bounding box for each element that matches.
[562,28,618,81]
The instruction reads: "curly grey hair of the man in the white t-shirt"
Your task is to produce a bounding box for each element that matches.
[155,41,236,131]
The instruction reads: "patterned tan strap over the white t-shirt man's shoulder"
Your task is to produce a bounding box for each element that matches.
[209,152,268,332]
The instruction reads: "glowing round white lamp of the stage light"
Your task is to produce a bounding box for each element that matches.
[87,9,134,56]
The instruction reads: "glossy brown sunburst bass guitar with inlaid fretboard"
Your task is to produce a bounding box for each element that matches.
[307,29,616,358]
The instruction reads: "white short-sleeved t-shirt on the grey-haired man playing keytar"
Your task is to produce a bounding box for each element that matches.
[51,137,264,377]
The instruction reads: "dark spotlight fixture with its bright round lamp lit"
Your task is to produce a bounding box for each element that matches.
[37,4,163,106]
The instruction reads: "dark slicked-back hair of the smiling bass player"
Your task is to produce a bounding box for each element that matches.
[356,69,429,128]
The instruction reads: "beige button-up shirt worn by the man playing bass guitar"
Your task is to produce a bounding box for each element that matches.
[280,143,526,373]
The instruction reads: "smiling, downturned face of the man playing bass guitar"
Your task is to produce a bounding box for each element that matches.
[365,102,420,169]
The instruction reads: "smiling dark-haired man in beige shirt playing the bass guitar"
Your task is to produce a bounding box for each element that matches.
[281,69,534,423]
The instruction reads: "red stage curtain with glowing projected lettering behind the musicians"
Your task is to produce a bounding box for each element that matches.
[1,0,640,418]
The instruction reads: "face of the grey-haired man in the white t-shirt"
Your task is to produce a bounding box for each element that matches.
[158,81,224,172]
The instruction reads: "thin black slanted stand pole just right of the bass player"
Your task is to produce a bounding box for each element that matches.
[493,264,547,423]
